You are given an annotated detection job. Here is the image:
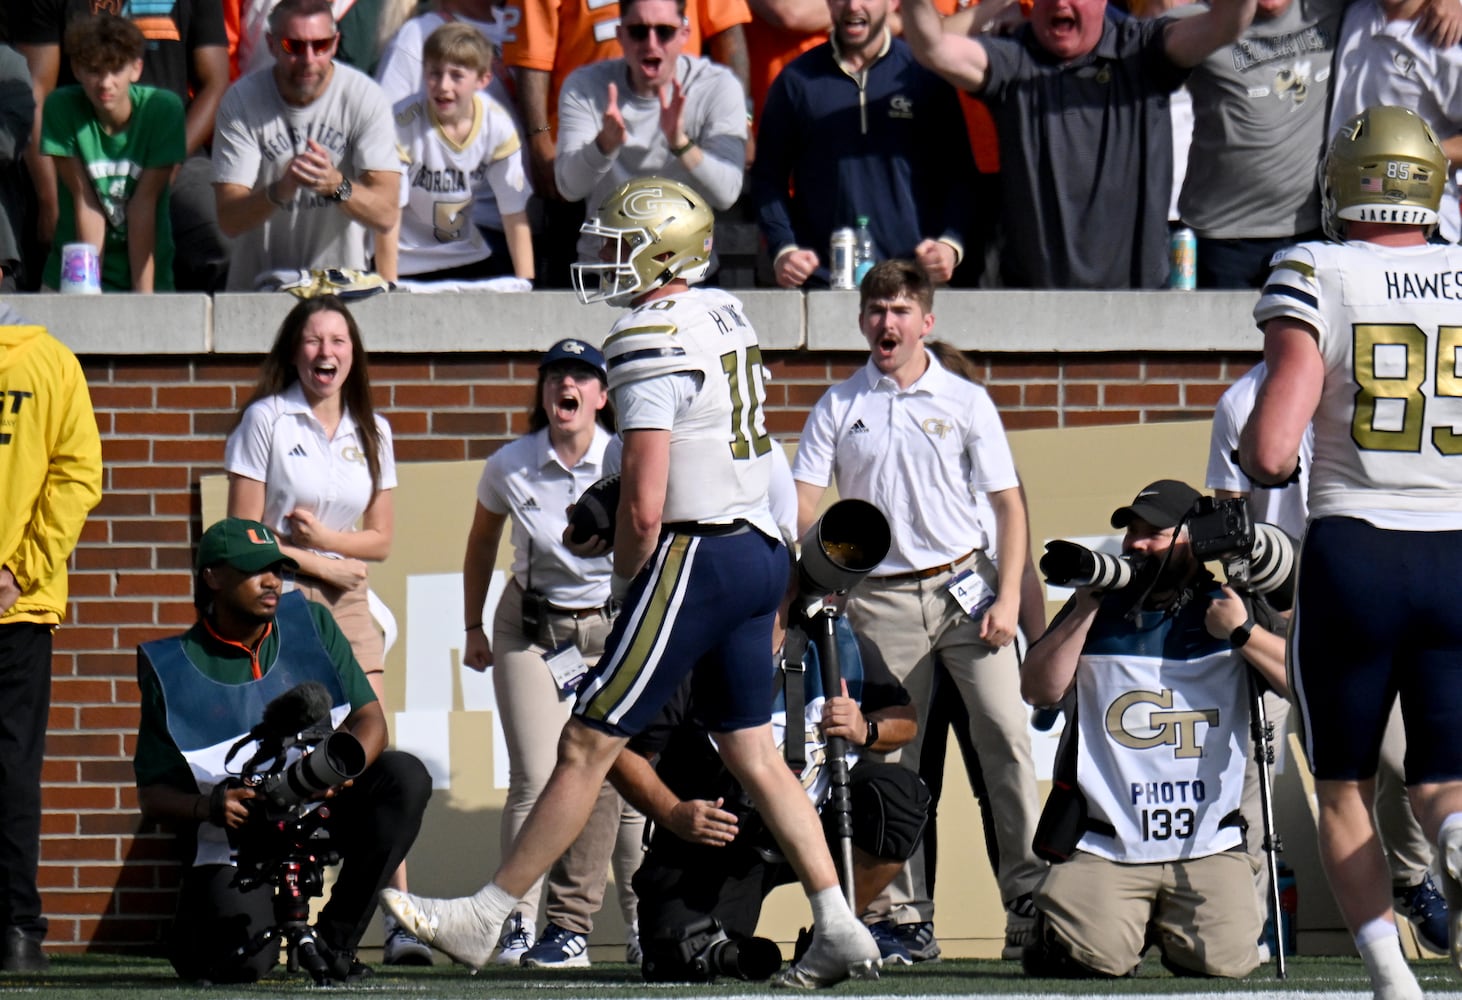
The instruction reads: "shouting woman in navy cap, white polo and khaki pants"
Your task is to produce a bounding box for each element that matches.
[462,339,645,966]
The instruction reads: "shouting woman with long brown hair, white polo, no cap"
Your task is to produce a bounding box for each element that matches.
[224,295,431,965]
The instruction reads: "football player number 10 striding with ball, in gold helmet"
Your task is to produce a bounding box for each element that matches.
[382,177,879,987]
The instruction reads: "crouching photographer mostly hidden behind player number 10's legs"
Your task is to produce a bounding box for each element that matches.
[610,590,928,982]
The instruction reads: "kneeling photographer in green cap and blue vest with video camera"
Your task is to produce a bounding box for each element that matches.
[133,518,431,982]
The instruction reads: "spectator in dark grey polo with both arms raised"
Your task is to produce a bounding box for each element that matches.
[904,0,1256,288]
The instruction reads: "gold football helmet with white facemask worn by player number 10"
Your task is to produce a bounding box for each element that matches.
[572,177,716,306]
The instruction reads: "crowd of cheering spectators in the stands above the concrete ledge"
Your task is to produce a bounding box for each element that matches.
[0,0,1462,291]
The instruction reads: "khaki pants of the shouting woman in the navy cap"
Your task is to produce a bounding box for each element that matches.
[493,580,645,934]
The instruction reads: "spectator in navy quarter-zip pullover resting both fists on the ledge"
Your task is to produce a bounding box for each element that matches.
[751,0,975,288]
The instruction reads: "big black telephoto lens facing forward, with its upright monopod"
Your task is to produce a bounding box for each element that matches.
[788,500,892,906]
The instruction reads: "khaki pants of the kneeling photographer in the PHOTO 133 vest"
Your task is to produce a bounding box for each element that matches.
[1035,851,1263,977]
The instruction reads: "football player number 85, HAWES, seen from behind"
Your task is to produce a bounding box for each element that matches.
[1240,107,1462,997]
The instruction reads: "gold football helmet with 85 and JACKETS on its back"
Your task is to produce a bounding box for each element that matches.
[1320,105,1447,241]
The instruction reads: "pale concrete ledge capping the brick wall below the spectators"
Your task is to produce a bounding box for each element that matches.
[7,289,1262,357]
